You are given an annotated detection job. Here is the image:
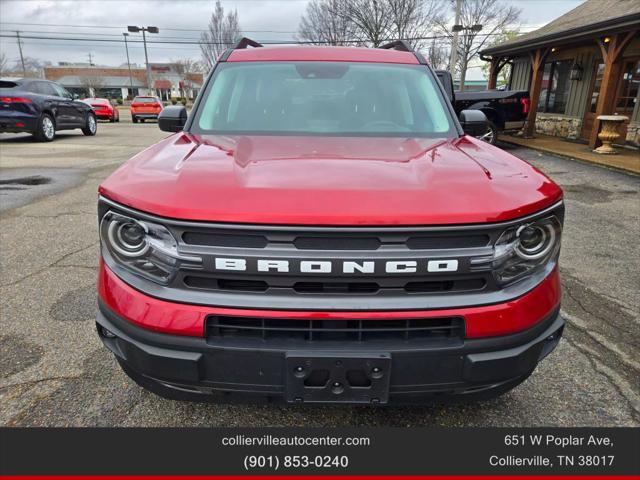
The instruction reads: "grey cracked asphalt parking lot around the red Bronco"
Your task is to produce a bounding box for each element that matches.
[0,115,640,426]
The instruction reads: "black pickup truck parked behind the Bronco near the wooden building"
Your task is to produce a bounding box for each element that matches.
[436,70,531,145]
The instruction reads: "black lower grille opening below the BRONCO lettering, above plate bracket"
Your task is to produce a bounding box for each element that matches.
[206,315,464,342]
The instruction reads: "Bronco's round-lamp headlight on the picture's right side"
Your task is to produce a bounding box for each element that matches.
[491,215,562,286]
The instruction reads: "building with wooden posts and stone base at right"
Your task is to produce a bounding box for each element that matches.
[481,0,640,147]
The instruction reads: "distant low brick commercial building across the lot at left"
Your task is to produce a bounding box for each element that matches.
[44,63,203,100]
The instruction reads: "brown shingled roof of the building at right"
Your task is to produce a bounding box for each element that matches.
[481,0,640,55]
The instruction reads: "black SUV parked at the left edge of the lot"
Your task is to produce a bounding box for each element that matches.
[0,78,98,142]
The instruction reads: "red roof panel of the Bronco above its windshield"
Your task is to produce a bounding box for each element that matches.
[226,46,420,65]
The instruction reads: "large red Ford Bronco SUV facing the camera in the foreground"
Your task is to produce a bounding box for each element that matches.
[97,40,564,405]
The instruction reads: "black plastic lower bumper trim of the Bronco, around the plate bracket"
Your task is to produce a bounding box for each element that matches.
[97,302,564,404]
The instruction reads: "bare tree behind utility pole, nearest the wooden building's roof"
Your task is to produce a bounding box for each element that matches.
[439,0,521,90]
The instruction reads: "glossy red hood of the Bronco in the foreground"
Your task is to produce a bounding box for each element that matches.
[100,133,562,225]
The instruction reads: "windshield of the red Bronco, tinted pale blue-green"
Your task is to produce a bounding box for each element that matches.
[191,62,456,137]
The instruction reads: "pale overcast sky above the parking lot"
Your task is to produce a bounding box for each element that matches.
[0,0,582,78]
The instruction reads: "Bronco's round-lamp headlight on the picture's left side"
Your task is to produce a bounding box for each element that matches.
[100,211,202,284]
